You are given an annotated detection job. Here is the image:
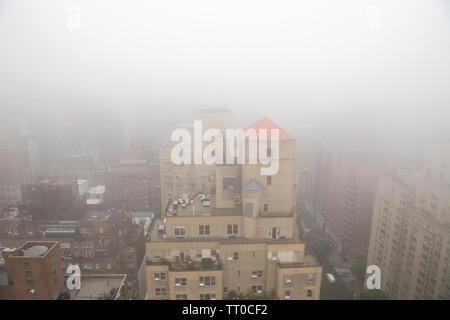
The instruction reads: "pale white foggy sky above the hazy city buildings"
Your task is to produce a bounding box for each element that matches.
[0,0,450,151]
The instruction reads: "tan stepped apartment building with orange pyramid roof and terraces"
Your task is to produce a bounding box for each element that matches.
[146,110,322,300]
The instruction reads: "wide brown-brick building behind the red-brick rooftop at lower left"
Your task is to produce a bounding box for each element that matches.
[0,206,146,298]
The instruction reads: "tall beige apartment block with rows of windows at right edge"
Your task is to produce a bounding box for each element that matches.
[367,142,450,299]
